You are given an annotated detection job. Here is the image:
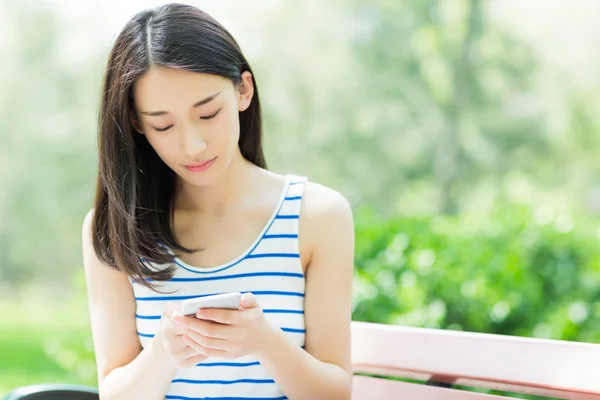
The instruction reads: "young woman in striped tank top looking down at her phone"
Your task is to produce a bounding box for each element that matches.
[83,4,354,400]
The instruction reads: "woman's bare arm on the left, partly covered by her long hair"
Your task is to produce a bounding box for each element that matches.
[82,212,176,400]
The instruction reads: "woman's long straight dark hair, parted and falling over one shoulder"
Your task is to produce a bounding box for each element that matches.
[92,4,266,290]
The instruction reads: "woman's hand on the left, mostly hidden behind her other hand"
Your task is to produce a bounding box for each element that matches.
[160,302,207,368]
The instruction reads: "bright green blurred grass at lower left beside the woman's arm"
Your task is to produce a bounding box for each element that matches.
[0,299,96,397]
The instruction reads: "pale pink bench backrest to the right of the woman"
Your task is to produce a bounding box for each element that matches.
[352,322,600,400]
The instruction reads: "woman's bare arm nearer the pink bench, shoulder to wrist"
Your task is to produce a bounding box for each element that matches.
[258,183,354,400]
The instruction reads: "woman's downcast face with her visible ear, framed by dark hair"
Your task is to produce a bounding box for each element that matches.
[132,67,253,186]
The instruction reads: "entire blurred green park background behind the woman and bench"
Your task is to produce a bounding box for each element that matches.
[0,0,600,398]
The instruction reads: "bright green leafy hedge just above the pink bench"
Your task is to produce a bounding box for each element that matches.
[354,208,600,342]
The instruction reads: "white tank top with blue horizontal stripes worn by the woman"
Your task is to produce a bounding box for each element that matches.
[130,175,307,400]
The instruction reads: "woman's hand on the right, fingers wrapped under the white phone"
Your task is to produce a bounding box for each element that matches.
[169,293,273,359]
